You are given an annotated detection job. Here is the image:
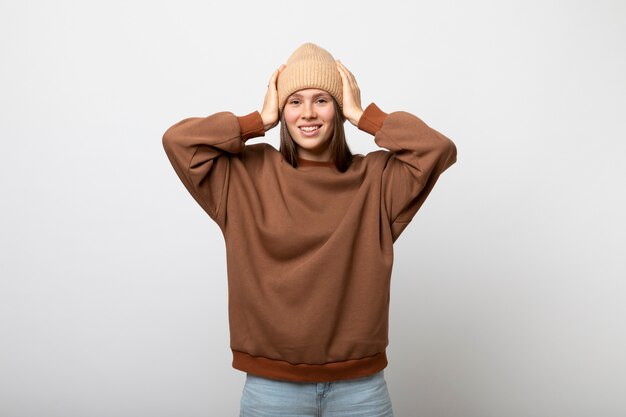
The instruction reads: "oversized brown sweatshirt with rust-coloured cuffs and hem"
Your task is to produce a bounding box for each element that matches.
[163,103,456,382]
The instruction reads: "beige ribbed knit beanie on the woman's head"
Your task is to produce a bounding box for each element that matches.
[278,43,343,111]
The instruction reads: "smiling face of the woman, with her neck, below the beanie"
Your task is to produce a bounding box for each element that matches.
[283,88,335,161]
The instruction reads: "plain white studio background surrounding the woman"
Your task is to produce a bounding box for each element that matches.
[0,0,626,417]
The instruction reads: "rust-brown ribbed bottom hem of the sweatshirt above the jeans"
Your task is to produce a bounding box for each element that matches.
[233,350,387,382]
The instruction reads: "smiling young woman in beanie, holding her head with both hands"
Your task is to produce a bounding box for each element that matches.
[163,43,456,416]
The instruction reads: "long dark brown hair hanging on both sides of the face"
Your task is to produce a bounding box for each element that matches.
[279,97,352,172]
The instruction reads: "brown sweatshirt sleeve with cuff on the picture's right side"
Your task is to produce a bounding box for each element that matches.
[358,103,456,241]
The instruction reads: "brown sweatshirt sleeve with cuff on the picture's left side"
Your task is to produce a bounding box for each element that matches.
[163,111,265,226]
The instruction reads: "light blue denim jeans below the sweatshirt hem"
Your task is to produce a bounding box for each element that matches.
[239,370,393,417]
